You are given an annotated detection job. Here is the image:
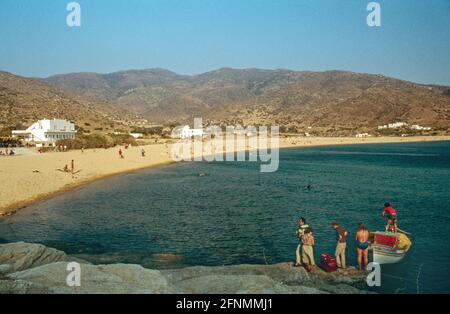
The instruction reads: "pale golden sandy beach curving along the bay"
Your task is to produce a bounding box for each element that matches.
[0,136,450,217]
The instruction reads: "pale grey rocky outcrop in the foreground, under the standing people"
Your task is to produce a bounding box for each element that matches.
[0,243,366,294]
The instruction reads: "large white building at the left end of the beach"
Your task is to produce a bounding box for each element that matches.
[12,119,77,146]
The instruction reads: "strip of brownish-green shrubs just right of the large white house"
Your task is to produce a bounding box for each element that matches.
[56,134,137,149]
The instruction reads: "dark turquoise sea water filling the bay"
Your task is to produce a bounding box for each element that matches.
[0,142,450,293]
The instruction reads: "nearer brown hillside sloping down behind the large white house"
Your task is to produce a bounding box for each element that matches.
[0,71,142,131]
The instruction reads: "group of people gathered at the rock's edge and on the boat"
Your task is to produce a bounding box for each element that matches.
[294,203,397,271]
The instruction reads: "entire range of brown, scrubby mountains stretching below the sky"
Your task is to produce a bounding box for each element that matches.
[0,68,450,135]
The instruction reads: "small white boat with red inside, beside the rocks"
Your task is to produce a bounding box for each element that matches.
[371,231,411,264]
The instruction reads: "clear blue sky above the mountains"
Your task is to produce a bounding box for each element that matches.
[0,0,450,85]
